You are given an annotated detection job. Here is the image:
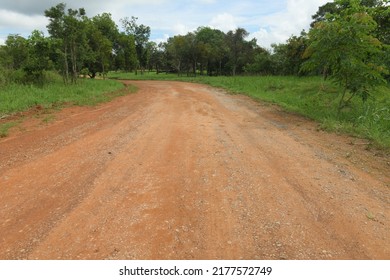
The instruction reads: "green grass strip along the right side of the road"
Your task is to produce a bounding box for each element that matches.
[110,72,390,151]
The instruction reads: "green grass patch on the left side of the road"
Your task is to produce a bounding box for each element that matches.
[0,79,135,117]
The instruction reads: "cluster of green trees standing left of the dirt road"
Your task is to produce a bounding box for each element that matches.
[0,3,145,85]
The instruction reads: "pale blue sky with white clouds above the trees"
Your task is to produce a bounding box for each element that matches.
[0,0,331,47]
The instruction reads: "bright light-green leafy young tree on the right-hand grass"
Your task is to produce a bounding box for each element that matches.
[302,0,386,110]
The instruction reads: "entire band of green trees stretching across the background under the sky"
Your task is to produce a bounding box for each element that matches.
[0,0,390,90]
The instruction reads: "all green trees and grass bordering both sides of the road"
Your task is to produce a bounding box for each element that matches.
[0,0,390,149]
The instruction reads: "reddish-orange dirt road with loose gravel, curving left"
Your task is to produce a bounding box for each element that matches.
[0,82,390,260]
